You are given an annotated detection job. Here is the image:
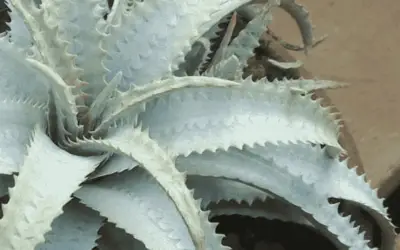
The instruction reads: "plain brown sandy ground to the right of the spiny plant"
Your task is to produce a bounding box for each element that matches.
[272,0,400,196]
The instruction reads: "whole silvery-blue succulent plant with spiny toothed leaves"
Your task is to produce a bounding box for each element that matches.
[0,0,394,250]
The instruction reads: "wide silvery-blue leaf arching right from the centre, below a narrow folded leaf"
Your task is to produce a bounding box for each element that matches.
[138,77,340,155]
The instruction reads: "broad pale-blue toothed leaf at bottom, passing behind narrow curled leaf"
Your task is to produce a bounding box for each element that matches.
[75,168,227,250]
